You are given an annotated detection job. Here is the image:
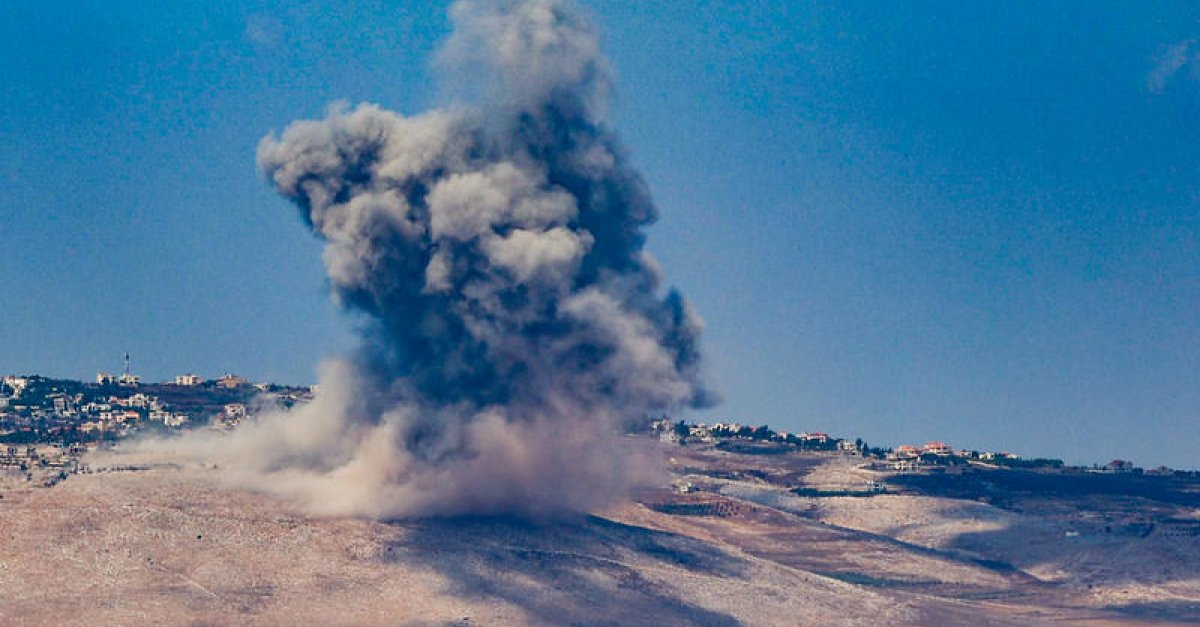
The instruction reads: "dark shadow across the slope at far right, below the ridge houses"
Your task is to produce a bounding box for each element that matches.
[887,471,1200,623]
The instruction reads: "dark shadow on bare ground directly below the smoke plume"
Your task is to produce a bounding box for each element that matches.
[384,516,748,626]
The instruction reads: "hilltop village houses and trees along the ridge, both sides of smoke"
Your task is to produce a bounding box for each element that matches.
[0,365,1177,482]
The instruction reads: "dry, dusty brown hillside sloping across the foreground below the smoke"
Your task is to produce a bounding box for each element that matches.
[0,447,1200,625]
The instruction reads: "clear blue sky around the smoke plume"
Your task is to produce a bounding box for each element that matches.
[0,0,1200,467]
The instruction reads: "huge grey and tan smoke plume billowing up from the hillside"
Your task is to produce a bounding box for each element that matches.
[151,0,709,518]
